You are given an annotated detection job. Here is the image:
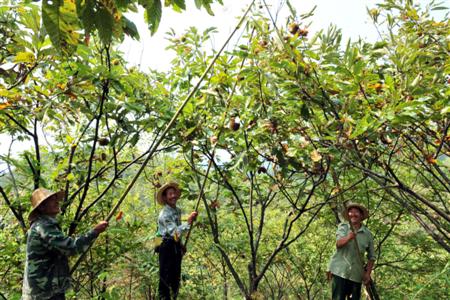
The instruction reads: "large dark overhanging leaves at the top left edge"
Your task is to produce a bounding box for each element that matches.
[37,0,221,49]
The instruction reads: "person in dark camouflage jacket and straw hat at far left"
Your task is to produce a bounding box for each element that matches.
[22,188,108,300]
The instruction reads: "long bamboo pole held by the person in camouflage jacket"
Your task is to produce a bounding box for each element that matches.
[70,0,255,275]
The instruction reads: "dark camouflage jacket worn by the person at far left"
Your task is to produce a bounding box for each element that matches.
[22,216,97,300]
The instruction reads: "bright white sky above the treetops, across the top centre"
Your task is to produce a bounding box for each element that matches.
[120,0,381,71]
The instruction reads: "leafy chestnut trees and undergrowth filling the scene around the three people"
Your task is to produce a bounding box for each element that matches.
[0,1,450,299]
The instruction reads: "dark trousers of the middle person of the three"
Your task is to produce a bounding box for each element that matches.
[159,239,183,300]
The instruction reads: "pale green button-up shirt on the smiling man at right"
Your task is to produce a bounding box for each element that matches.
[328,223,375,282]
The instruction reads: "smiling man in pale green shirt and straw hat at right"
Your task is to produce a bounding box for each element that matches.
[328,203,375,300]
